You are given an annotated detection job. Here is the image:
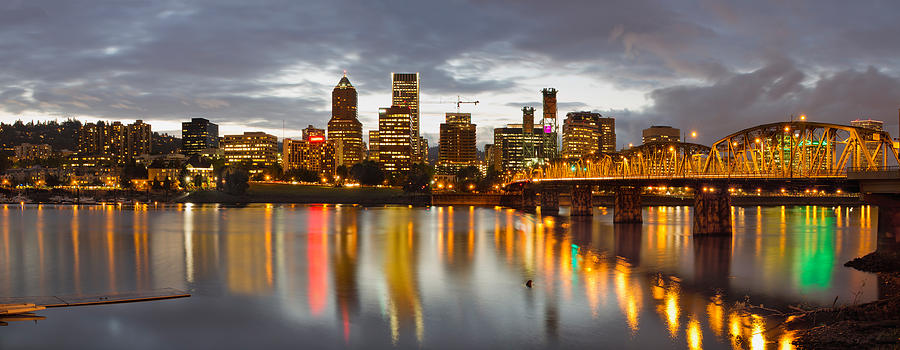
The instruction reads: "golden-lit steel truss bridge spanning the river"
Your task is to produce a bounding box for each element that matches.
[510,121,900,190]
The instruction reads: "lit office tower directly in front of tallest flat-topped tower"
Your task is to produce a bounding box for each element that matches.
[378,106,418,176]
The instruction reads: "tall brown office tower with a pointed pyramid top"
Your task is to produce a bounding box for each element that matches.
[328,73,364,167]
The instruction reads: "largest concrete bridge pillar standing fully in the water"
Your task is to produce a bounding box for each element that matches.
[693,189,732,235]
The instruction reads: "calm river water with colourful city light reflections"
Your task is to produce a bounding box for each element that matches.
[0,205,878,350]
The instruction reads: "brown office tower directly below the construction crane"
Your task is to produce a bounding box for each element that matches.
[438,113,478,174]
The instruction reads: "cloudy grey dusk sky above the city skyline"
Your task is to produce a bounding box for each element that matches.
[0,0,900,146]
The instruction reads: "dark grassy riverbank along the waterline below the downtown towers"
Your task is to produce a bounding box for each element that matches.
[175,183,430,205]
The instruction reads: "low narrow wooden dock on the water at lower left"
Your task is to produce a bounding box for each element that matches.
[0,288,191,308]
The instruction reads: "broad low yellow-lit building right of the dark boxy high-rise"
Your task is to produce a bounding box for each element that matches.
[223,132,278,174]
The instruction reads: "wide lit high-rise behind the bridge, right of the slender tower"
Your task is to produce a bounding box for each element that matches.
[562,112,616,158]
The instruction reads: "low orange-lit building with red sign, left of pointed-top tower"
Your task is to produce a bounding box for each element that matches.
[282,135,338,175]
